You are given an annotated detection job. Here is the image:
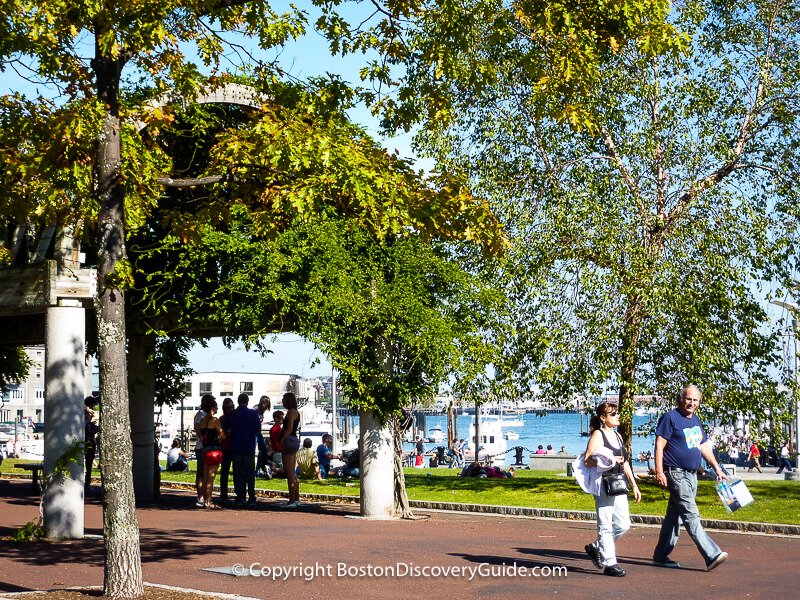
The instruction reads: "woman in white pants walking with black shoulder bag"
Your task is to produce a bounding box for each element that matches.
[576,402,642,577]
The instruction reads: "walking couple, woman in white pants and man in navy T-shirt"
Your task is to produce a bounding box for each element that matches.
[574,385,728,577]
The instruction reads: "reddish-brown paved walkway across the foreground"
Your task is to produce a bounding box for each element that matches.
[0,481,800,600]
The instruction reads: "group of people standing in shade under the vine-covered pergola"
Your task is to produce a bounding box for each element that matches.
[194,392,300,509]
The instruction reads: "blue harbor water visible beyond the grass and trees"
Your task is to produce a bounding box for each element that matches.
[405,413,655,464]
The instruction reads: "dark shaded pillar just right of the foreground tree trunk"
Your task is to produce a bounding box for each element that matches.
[128,334,156,500]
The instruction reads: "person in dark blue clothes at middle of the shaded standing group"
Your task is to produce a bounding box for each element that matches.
[225,394,261,507]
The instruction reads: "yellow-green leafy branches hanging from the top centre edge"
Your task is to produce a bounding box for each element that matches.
[314,0,682,130]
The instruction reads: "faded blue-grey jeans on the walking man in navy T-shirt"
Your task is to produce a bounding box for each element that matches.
[653,467,721,564]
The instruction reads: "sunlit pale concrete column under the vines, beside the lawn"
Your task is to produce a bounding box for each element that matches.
[359,410,394,519]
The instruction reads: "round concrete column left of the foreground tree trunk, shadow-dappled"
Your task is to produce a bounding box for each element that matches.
[43,301,86,539]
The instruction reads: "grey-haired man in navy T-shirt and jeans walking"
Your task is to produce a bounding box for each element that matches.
[653,385,728,571]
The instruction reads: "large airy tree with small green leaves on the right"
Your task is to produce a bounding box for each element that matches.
[412,0,800,442]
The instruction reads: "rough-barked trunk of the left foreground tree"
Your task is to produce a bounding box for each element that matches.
[92,50,144,598]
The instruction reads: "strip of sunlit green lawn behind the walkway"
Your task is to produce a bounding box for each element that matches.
[0,459,800,525]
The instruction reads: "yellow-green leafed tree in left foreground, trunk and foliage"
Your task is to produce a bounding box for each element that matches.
[0,0,502,598]
